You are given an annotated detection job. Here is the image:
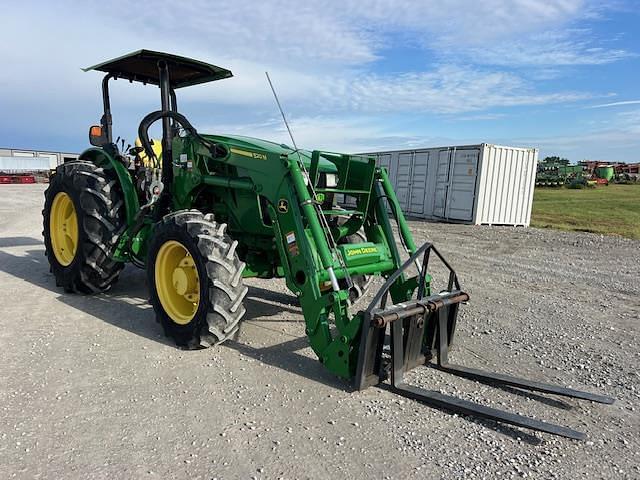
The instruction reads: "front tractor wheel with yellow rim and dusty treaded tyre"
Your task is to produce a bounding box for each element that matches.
[147,210,248,349]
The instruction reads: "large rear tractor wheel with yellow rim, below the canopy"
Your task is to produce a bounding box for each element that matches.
[42,160,126,293]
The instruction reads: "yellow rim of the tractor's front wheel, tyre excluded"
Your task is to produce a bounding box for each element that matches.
[155,240,200,325]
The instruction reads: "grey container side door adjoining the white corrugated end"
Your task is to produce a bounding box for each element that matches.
[446,149,480,221]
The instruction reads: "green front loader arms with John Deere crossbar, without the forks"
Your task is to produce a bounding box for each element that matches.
[262,151,428,380]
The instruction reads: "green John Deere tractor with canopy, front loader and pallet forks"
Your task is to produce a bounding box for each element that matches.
[43,50,613,438]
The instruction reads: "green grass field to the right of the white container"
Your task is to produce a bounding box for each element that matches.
[531,185,640,240]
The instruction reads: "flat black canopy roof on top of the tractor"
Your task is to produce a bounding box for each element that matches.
[82,50,233,88]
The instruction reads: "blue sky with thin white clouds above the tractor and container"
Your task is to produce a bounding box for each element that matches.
[0,0,640,162]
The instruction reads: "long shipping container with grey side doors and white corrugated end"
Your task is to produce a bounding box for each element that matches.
[363,143,538,226]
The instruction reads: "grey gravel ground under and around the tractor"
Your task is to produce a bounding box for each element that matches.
[0,185,640,479]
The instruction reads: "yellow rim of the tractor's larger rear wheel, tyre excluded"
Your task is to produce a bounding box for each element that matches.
[49,192,78,267]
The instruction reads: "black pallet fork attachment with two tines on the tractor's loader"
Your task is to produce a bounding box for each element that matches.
[354,243,614,440]
